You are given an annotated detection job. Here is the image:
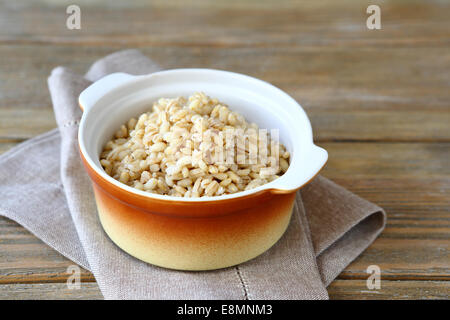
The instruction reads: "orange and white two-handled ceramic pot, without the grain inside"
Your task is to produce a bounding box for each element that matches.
[78,69,327,270]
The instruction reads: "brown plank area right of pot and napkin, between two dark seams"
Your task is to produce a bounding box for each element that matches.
[321,143,450,280]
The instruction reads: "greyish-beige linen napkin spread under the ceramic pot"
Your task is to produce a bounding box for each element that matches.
[0,50,386,299]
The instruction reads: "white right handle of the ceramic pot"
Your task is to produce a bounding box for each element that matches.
[269,145,328,194]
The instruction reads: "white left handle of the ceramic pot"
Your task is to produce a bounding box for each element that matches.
[78,72,134,112]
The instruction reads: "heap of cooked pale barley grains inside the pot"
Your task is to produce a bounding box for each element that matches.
[100,93,290,197]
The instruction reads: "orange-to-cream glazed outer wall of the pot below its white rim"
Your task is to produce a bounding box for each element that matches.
[85,152,295,270]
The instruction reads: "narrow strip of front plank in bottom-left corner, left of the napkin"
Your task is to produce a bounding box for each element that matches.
[0,282,103,300]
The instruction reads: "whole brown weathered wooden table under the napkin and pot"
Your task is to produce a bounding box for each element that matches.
[0,0,450,299]
